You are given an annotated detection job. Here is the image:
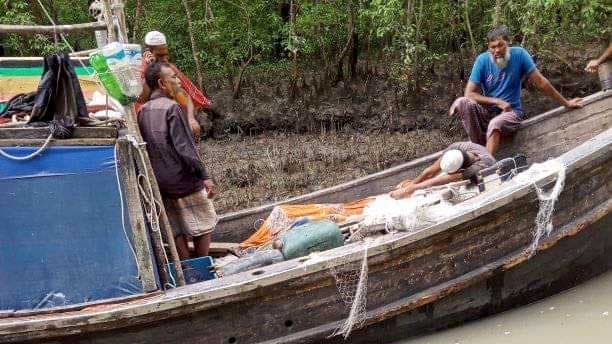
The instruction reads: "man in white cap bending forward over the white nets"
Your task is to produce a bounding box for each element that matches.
[390,142,496,199]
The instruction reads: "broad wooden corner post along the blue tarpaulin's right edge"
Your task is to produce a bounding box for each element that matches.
[117,138,158,293]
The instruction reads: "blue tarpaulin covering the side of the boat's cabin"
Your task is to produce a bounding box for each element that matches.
[0,146,143,310]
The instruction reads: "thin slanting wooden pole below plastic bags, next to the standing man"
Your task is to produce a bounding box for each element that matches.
[125,105,185,286]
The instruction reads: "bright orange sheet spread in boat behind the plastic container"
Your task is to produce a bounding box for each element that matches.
[240,197,374,248]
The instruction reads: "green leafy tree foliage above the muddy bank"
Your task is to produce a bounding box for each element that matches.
[0,0,612,81]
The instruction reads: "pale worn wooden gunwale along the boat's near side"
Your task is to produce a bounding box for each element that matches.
[0,120,612,339]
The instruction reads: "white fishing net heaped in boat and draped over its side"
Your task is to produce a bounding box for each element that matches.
[331,160,565,339]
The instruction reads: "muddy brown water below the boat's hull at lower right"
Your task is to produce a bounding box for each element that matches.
[395,271,612,344]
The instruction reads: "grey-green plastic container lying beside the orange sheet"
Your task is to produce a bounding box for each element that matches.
[280,220,344,260]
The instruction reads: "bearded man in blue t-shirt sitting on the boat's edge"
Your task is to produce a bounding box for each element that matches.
[450,26,581,154]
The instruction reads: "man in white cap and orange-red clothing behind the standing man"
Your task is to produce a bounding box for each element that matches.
[136,31,210,140]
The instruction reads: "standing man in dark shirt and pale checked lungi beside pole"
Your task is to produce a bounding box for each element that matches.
[138,62,217,259]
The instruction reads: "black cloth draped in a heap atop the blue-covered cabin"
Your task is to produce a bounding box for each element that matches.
[29,54,87,138]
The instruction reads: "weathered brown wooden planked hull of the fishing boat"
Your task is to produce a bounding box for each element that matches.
[0,80,612,343]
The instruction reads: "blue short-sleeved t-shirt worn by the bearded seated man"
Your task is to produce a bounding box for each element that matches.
[470,47,536,117]
